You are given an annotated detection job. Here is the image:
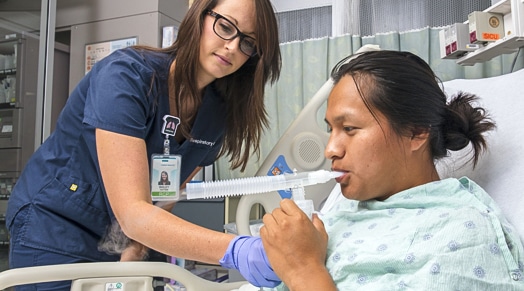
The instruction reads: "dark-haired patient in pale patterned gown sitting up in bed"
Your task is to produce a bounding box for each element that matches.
[260,51,524,291]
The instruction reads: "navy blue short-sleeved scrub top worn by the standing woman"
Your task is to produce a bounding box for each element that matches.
[6,48,226,261]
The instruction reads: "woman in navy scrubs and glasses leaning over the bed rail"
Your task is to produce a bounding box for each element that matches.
[7,0,281,290]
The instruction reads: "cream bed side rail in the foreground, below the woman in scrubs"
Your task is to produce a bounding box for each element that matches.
[0,262,247,291]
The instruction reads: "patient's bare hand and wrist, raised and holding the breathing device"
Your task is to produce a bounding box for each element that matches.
[260,199,336,290]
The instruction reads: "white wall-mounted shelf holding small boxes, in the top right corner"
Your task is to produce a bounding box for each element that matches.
[456,0,524,66]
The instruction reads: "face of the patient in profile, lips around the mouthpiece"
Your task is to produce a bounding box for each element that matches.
[325,76,410,201]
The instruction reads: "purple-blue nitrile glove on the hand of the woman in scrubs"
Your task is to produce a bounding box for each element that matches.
[220,236,281,288]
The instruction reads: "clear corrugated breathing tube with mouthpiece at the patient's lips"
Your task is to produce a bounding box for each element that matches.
[185,170,342,217]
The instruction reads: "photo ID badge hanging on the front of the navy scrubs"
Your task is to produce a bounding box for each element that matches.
[151,155,182,201]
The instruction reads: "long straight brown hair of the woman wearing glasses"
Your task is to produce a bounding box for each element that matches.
[138,0,281,171]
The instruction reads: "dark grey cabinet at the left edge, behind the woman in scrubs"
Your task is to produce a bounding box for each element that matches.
[0,36,69,271]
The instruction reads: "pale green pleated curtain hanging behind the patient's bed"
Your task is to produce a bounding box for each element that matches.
[215,28,524,179]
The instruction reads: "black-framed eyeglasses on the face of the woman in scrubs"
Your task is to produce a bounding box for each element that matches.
[206,10,257,57]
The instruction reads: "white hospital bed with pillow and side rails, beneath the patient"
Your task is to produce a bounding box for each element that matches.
[0,52,524,291]
